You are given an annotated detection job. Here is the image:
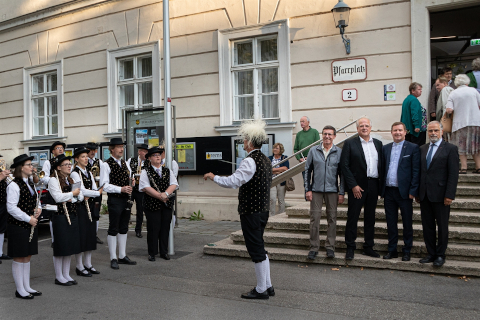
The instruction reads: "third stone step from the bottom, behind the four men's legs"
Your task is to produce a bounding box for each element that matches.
[266,214,480,244]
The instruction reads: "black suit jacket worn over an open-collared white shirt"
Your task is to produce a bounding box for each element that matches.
[340,136,383,195]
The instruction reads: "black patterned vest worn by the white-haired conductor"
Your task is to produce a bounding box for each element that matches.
[238,150,272,214]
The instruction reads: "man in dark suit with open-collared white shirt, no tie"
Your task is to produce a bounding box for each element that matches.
[340,118,383,260]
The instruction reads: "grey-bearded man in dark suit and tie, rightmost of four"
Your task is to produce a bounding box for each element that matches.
[415,121,459,267]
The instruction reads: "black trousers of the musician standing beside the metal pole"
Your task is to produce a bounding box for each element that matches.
[145,206,172,256]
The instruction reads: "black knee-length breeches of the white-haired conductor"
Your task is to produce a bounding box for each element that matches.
[240,211,268,263]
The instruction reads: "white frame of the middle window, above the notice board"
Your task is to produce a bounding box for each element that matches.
[107,41,161,134]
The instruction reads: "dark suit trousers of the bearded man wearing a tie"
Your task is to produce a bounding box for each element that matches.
[420,196,450,258]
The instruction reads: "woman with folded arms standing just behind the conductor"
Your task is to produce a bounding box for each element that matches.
[268,143,290,216]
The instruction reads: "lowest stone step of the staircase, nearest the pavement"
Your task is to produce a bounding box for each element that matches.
[203,239,480,277]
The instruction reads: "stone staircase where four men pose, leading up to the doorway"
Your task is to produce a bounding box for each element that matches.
[204,169,480,276]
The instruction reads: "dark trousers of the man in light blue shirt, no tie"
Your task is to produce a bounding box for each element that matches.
[385,187,413,253]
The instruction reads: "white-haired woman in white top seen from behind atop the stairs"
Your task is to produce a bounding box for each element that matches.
[447,74,480,174]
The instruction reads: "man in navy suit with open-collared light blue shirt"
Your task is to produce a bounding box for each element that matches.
[382,122,420,261]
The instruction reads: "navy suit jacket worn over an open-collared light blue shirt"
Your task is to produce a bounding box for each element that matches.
[382,141,420,199]
